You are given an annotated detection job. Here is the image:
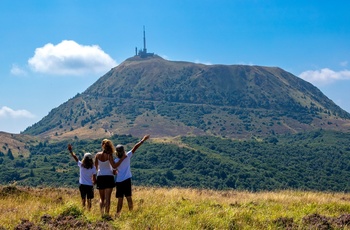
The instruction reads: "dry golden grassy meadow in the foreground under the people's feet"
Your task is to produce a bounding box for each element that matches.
[0,185,350,229]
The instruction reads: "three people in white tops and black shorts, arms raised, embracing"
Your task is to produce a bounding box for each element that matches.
[68,135,150,218]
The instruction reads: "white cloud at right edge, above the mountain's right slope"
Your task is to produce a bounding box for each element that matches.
[299,68,350,85]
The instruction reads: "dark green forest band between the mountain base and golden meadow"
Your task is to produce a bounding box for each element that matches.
[0,130,350,192]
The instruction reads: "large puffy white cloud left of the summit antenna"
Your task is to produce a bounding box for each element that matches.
[28,40,117,75]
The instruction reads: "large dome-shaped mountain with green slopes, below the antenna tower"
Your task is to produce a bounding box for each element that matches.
[23,55,350,139]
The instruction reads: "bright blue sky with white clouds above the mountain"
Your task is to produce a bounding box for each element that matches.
[0,0,350,133]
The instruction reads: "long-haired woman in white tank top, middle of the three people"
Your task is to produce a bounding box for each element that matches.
[95,139,125,219]
